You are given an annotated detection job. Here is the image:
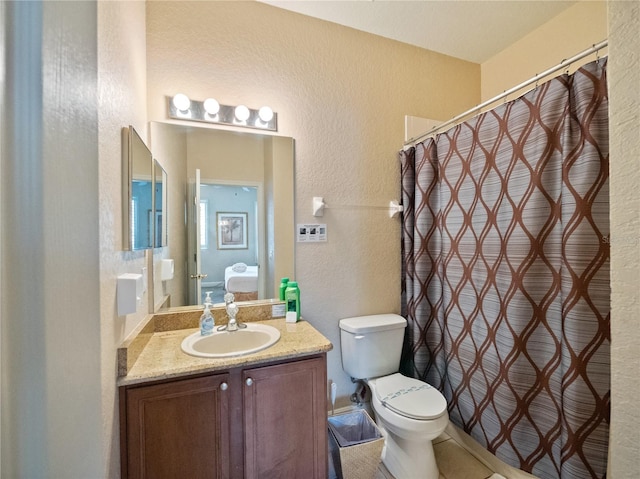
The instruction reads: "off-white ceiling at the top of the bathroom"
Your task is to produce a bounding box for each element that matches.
[261,0,576,63]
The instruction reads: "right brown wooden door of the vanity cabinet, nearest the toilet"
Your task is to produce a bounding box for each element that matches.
[243,356,327,479]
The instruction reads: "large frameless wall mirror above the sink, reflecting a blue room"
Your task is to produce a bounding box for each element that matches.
[150,122,295,307]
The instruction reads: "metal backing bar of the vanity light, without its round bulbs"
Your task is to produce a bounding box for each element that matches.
[166,96,278,131]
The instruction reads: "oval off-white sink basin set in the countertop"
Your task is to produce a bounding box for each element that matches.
[181,323,280,358]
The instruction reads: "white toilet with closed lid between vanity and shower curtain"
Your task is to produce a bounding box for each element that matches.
[340,314,449,479]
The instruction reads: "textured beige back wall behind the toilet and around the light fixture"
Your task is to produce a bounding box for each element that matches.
[147,1,480,399]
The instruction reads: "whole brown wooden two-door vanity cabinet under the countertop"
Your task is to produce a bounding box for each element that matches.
[120,354,327,479]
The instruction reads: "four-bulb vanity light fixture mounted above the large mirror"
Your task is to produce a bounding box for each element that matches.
[166,93,278,131]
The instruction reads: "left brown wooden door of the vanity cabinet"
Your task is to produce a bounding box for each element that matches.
[123,374,229,479]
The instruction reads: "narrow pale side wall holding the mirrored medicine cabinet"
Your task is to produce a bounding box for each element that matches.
[97,2,148,477]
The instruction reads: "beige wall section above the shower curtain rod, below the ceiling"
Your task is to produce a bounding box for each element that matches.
[481,1,607,101]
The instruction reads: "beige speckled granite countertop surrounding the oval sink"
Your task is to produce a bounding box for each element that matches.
[118,318,333,386]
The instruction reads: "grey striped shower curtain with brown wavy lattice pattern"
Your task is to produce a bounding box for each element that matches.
[399,59,610,479]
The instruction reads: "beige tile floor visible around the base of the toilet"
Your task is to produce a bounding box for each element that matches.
[375,432,493,479]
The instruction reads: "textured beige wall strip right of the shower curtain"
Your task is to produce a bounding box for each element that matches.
[608,1,640,479]
